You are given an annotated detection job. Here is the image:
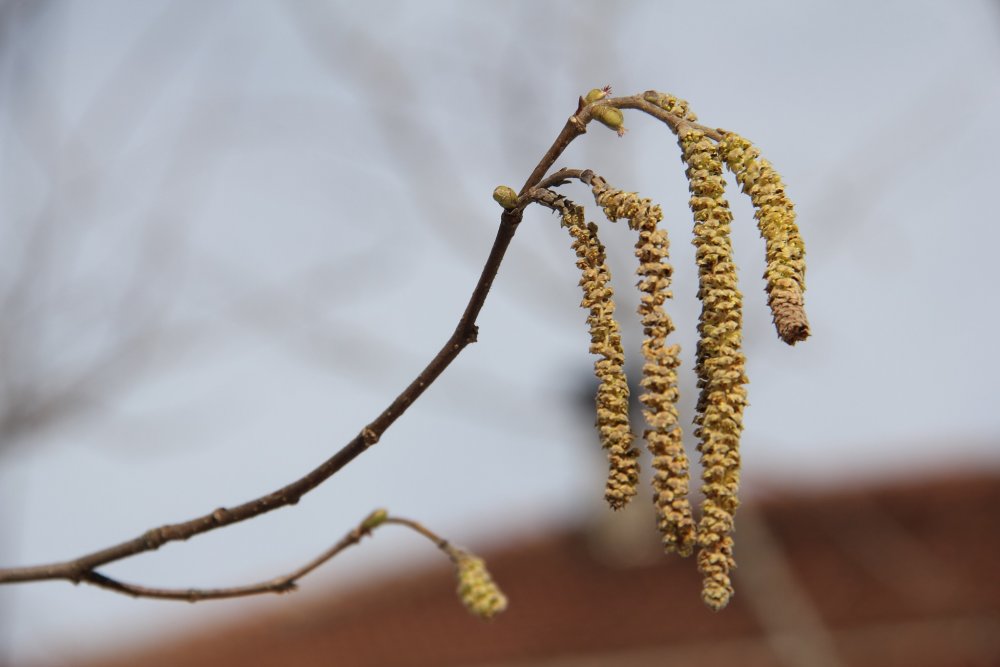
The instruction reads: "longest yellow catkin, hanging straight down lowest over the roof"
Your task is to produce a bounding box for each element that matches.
[680,128,747,609]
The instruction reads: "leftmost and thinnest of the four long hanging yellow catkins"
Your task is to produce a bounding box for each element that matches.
[562,200,639,510]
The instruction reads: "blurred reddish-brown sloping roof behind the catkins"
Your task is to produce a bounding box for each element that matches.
[76,476,1000,667]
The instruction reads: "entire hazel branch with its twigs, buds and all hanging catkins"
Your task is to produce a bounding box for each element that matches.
[0,86,809,619]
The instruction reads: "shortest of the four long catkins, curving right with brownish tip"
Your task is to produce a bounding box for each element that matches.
[719,132,809,345]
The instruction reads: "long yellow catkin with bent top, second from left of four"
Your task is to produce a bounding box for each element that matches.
[591,177,695,556]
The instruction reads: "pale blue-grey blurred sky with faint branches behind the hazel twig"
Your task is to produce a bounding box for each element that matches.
[0,0,1000,664]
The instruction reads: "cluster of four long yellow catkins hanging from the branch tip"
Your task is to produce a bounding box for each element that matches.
[497,89,809,609]
